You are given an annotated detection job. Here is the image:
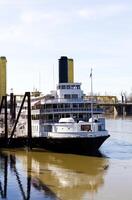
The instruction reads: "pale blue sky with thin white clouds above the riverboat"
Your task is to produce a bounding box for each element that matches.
[0,0,132,96]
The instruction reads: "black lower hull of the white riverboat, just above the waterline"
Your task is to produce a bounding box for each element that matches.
[0,135,109,153]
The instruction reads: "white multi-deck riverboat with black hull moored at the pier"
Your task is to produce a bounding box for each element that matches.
[18,56,109,153]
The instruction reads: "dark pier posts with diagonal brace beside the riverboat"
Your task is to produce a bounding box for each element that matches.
[0,92,32,149]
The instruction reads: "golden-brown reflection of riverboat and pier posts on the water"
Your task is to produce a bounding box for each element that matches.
[0,150,109,200]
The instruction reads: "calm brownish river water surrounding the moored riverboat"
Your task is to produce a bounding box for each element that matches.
[0,118,132,200]
